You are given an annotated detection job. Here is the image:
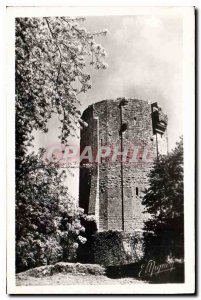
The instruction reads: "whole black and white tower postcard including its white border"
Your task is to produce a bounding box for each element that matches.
[7,7,195,294]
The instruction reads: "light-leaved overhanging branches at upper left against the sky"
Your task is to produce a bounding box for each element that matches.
[16,17,107,155]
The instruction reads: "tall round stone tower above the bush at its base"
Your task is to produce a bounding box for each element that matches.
[79,98,168,233]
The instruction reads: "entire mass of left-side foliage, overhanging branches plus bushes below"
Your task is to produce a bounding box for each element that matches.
[15,17,107,271]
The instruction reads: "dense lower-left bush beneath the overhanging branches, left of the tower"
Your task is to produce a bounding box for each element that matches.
[16,150,90,271]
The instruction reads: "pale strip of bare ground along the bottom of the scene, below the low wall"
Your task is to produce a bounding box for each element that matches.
[16,274,146,286]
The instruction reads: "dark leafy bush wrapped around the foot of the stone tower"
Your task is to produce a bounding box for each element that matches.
[78,230,144,266]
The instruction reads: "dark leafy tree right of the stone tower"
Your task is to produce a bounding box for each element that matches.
[142,138,184,258]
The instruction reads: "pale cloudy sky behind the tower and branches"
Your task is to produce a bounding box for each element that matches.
[34,15,182,196]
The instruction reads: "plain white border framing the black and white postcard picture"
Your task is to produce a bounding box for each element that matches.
[6,7,195,294]
